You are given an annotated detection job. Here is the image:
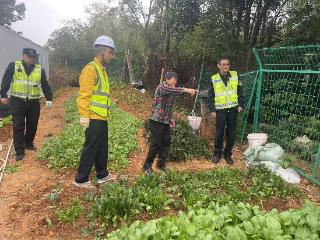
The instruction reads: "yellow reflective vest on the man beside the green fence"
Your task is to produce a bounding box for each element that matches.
[211,71,239,110]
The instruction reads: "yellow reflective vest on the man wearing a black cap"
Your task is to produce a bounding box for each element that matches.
[11,61,41,99]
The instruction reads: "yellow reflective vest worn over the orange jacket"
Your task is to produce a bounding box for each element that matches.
[89,61,111,117]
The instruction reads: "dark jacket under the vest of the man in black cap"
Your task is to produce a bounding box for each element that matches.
[0,61,52,101]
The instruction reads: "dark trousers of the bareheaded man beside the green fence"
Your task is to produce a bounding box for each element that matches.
[214,108,238,156]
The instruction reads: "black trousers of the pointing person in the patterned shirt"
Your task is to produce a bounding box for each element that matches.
[143,120,171,169]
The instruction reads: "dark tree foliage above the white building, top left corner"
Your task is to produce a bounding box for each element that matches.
[0,0,26,28]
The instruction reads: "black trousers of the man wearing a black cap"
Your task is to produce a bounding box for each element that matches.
[10,97,40,154]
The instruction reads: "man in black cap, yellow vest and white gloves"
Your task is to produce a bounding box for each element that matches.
[0,48,52,161]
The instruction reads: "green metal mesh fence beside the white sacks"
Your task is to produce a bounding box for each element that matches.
[242,45,320,185]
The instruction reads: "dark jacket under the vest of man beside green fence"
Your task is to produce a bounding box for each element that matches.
[208,72,245,112]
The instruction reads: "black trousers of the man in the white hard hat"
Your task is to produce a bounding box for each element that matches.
[75,119,109,183]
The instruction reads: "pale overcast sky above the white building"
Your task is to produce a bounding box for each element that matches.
[12,0,102,46]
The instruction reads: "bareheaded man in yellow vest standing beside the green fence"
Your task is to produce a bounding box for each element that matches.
[208,57,244,165]
